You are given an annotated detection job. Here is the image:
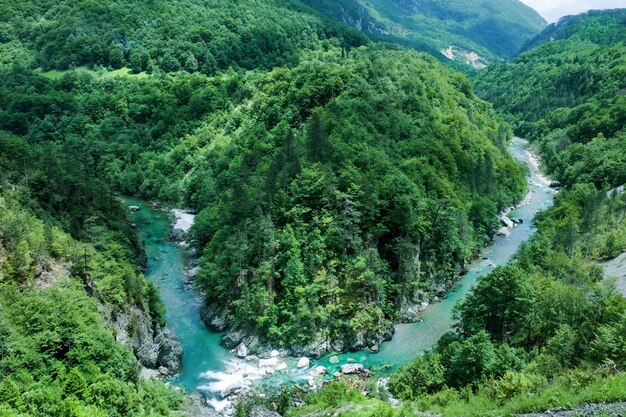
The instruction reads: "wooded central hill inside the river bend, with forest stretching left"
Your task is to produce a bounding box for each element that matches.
[0,39,524,349]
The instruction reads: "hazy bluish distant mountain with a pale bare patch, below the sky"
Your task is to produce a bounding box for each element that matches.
[294,0,546,65]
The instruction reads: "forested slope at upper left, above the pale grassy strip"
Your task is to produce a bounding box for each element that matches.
[0,0,366,74]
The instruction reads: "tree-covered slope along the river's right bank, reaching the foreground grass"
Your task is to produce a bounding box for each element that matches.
[276,11,626,416]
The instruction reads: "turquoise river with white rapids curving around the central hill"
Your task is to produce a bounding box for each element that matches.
[120,138,555,409]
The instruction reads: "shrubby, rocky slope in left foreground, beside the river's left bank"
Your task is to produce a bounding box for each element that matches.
[0,131,181,417]
